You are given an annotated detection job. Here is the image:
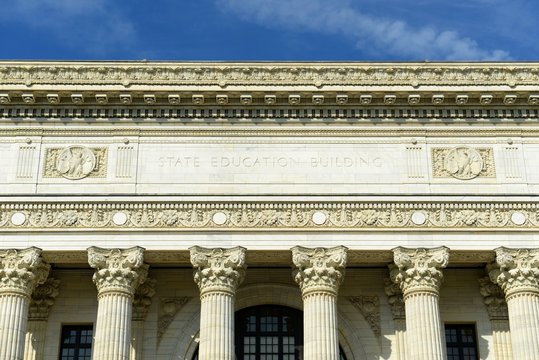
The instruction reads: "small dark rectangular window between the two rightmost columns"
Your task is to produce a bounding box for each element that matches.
[445,324,479,360]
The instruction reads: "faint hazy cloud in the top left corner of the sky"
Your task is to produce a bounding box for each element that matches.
[0,0,134,53]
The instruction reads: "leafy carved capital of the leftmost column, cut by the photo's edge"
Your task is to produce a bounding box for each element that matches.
[0,247,50,297]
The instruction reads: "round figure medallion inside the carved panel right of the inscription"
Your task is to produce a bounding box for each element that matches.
[444,146,483,180]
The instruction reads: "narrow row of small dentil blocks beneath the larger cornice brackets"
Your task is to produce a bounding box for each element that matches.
[0,106,539,123]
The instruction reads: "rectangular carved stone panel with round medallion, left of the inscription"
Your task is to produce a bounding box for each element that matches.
[43,146,108,180]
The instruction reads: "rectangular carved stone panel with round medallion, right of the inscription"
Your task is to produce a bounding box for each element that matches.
[432,146,496,180]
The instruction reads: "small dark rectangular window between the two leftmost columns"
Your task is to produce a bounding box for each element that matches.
[60,325,94,360]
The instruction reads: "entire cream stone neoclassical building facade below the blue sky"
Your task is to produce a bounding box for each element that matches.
[0,61,539,360]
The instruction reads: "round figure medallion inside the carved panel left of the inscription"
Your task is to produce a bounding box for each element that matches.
[56,146,96,180]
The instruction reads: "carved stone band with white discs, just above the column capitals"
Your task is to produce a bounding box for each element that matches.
[0,201,539,232]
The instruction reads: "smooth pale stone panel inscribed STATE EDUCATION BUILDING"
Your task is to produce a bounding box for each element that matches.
[138,143,403,185]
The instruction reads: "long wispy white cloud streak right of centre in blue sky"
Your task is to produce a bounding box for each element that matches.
[216,0,509,60]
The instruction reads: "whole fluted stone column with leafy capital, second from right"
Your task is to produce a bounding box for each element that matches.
[390,246,449,360]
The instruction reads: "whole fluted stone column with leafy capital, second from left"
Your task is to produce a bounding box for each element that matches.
[88,247,148,360]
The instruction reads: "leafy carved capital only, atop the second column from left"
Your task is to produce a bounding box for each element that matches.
[88,246,148,297]
